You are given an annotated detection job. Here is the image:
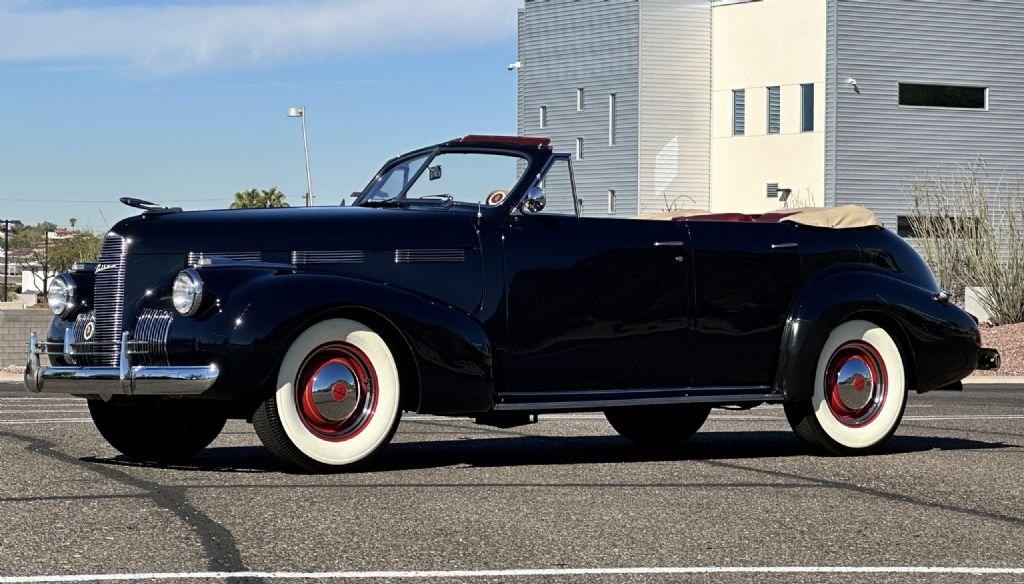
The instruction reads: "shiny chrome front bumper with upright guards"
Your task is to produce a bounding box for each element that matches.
[25,333,220,395]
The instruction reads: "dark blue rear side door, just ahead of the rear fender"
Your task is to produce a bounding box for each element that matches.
[687,221,803,387]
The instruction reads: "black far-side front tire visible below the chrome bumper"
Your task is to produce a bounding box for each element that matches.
[89,399,227,462]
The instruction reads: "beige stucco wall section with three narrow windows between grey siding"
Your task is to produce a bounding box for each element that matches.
[712,0,825,212]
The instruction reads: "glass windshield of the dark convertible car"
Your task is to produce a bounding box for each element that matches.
[364,153,526,206]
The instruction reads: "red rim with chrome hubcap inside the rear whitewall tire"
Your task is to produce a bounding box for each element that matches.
[824,341,889,427]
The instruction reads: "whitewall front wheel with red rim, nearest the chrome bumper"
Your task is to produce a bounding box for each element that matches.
[253,319,401,471]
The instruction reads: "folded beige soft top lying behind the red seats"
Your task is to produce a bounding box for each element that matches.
[639,205,882,230]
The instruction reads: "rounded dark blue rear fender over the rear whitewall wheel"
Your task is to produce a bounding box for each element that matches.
[776,270,981,400]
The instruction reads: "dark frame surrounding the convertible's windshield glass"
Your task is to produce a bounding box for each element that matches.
[352,144,551,210]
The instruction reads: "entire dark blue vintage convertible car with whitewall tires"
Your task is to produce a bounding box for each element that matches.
[26,136,998,470]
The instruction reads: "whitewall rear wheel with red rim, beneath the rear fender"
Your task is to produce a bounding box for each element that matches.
[784,321,907,455]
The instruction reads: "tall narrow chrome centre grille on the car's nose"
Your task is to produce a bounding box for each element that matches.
[92,233,128,366]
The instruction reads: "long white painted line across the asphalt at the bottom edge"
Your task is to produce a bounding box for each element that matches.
[0,566,1024,584]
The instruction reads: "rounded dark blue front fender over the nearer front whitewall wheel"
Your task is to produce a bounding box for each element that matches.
[172,268,495,414]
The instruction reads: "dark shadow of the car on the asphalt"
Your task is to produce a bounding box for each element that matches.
[75,428,1019,473]
